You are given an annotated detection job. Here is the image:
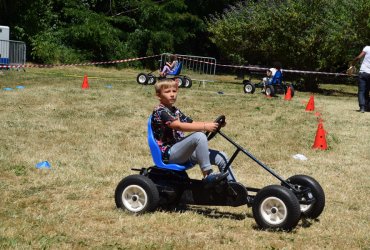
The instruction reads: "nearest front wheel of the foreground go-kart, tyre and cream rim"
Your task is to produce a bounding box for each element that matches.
[252,185,301,231]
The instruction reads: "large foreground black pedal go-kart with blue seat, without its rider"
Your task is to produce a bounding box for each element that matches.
[115,116,325,231]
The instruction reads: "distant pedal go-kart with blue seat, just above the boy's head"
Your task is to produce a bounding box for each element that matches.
[136,62,193,88]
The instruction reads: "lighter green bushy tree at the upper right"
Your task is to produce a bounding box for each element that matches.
[208,0,370,71]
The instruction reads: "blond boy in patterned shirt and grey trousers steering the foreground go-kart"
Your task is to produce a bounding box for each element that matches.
[151,79,235,182]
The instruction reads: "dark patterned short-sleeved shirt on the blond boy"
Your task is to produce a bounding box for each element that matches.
[152,104,193,161]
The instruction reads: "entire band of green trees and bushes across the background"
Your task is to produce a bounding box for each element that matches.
[0,0,370,72]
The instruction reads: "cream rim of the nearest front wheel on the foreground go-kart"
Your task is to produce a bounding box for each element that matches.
[260,197,288,225]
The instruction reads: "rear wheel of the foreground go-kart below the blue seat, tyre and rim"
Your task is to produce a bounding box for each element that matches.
[114,175,159,214]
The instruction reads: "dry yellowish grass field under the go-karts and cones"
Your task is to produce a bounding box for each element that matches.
[0,67,370,249]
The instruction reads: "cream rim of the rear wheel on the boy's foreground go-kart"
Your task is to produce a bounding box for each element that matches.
[122,185,148,212]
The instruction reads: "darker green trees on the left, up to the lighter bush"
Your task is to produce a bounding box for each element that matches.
[0,0,237,66]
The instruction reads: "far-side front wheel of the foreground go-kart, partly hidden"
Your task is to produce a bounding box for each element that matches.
[287,175,325,219]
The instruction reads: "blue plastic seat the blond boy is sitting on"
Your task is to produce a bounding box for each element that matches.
[148,116,193,171]
